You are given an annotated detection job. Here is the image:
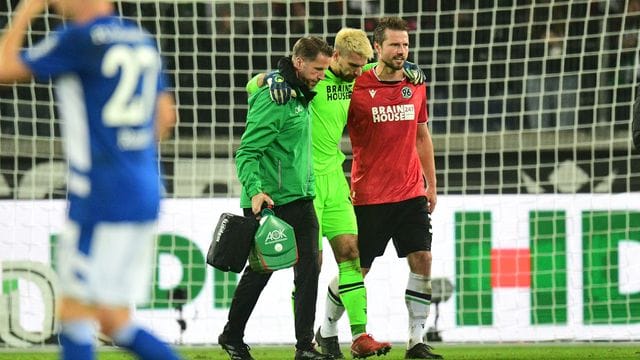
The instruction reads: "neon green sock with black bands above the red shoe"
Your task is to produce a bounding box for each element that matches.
[338,259,367,337]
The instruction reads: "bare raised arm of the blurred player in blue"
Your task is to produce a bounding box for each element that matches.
[0,0,47,84]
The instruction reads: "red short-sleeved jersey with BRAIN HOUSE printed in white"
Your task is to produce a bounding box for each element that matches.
[347,69,428,205]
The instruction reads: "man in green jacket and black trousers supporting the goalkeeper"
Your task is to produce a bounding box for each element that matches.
[218,36,333,360]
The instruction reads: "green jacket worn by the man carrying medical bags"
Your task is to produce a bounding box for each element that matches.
[236,82,315,208]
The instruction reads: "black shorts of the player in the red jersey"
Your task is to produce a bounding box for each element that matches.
[354,196,431,268]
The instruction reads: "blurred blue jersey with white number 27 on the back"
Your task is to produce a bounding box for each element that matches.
[21,16,165,223]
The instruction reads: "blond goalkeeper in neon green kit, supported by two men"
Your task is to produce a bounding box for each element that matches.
[247,28,424,358]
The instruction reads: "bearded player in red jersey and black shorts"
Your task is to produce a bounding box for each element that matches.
[347,17,442,359]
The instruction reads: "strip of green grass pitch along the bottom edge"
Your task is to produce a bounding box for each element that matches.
[0,343,640,360]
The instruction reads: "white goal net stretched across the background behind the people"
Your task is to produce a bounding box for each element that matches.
[0,0,640,346]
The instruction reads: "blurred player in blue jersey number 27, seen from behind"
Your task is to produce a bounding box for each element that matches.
[0,0,178,360]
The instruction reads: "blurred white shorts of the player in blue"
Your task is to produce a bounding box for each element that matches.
[56,220,157,307]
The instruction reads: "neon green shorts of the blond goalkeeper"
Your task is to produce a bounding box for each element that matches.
[313,169,358,250]
